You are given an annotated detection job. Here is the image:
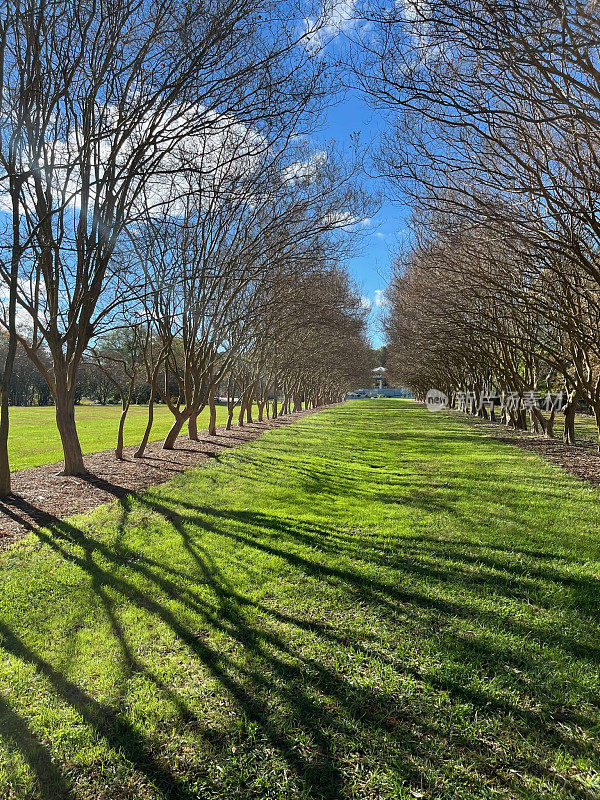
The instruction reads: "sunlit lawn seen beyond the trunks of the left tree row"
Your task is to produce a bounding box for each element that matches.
[9,405,232,469]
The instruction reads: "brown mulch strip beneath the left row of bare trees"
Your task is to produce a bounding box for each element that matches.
[0,410,324,550]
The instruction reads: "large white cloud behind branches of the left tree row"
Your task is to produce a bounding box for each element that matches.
[0,105,266,222]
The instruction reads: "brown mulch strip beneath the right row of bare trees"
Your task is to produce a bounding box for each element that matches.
[451,412,600,486]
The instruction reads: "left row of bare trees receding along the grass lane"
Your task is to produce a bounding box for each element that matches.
[0,0,370,494]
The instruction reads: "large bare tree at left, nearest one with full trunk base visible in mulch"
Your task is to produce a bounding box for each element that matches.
[2,0,330,474]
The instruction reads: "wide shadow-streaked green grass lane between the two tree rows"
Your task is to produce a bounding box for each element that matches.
[0,400,600,800]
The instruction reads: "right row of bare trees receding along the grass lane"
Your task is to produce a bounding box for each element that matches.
[359,0,600,450]
